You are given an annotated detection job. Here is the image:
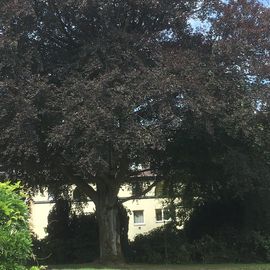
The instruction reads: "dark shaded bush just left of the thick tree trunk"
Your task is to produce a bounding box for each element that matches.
[33,199,99,264]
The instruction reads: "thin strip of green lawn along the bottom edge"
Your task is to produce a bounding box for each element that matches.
[49,264,270,270]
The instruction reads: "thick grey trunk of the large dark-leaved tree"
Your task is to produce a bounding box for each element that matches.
[96,184,123,263]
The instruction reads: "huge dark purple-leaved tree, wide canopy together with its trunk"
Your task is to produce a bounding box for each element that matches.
[0,0,270,259]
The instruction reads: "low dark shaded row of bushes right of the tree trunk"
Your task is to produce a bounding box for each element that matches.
[130,226,270,263]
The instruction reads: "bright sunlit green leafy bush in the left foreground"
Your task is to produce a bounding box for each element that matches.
[0,182,31,270]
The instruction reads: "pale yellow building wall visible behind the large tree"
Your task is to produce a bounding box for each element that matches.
[31,186,169,240]
